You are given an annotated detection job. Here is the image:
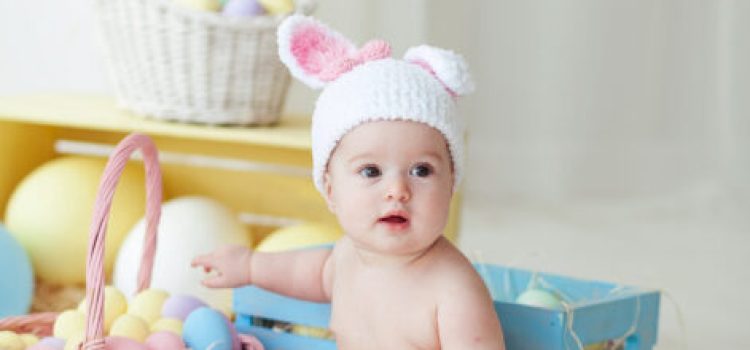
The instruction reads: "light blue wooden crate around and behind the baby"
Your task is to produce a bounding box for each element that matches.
[234,264,660,350]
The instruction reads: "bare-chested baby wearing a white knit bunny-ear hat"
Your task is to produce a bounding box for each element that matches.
[193,15,505,350]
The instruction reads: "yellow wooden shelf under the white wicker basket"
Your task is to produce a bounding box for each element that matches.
[0,93,460,242]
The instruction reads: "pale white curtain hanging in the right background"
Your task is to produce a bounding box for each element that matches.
[452,0,750,201]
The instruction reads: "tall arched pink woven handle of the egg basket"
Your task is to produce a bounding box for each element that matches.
[83,133,162,350]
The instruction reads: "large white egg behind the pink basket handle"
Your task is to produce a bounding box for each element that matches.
[113,197,252,310]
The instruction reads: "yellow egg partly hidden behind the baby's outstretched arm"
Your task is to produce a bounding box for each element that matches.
[255,223,343,252]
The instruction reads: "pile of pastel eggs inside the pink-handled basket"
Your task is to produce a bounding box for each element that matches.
[17,286,241,350]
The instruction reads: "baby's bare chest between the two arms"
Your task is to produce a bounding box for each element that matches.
[331,274,439,349]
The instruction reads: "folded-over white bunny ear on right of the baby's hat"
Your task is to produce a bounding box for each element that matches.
[404,45,474,96]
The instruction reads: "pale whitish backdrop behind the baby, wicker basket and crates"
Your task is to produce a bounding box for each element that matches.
[0,0,750,350]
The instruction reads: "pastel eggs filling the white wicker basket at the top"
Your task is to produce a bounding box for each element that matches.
[176,0,302,17]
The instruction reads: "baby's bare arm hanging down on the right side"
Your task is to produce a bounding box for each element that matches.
[437,273,505,350]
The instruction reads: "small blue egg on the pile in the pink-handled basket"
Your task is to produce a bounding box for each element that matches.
[182,307,232,350]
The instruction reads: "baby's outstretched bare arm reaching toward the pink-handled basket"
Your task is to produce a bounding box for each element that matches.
[192,246,332,302]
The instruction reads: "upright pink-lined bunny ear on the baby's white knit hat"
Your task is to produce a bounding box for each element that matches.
[278,15,357,89]
